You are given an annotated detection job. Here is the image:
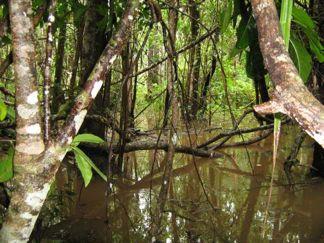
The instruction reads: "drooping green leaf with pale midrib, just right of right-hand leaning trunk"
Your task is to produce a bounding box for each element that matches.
[290,36,312,82]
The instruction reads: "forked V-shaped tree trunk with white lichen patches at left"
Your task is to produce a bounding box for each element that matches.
[0,0,138,243]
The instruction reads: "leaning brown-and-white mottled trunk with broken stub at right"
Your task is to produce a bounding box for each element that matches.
[251,0,324,147]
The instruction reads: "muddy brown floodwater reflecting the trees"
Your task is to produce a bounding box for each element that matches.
[36,126,324,242]
